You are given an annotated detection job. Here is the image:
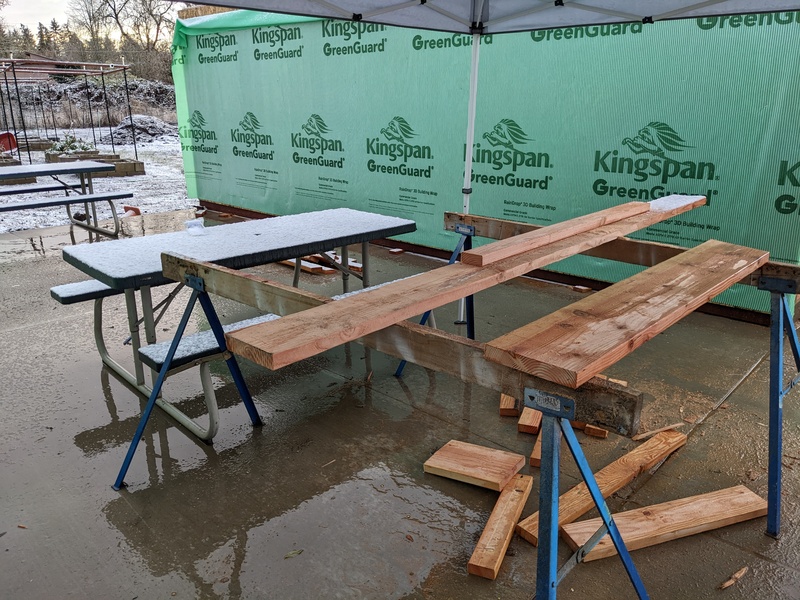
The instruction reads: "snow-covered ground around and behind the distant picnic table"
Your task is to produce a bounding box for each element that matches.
[0,129,196,233]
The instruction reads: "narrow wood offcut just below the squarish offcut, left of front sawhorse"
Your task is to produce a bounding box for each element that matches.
[467,475,533,579]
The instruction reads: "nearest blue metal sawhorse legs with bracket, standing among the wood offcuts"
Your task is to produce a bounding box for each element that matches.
[525,388,649,600]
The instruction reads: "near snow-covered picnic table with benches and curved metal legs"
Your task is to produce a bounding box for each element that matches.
[57,208,416,440]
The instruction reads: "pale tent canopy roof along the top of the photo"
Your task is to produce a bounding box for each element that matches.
[178,0,800,34]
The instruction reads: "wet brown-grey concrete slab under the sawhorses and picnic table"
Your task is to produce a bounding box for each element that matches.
[0,213,800,599]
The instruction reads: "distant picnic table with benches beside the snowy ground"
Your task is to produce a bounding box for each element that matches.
[0,160,133,238]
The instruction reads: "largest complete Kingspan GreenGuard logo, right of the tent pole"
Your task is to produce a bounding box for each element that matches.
[593,121,719,204]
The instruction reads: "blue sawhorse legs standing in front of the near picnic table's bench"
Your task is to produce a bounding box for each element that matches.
[112,275,262,490]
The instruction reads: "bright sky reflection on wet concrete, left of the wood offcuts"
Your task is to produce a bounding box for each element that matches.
[228,464,482,598]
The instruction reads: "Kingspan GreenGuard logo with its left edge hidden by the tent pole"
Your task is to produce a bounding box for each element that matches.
[464,119,553,190]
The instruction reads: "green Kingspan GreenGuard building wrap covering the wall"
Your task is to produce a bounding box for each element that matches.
[173,11,800,312]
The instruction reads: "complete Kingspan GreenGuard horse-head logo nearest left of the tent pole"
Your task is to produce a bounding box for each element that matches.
[367,116,433,179]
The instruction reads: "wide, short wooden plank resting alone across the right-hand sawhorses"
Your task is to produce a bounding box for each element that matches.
[486,240,769,388]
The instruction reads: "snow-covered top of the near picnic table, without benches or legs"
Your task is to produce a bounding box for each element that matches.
[64,208,416,289]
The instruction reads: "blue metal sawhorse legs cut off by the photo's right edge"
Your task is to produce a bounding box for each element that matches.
[758,277,800,538]
